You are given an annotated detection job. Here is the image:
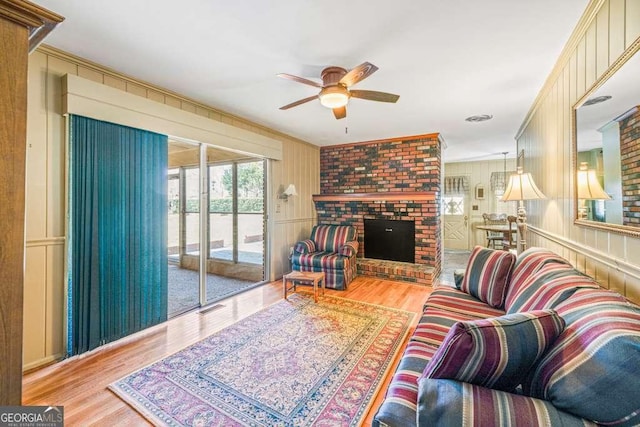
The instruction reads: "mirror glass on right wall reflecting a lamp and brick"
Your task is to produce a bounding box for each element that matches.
[573,43,640,237]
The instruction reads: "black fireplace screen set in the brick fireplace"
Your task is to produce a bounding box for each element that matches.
[364,219,416,263]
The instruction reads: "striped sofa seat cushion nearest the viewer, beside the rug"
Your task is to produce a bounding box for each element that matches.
[373,341,436,426]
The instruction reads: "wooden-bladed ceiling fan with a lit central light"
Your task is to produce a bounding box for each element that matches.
[278,62,400,119]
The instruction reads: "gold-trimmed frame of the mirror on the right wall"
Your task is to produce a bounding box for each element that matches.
[571,38,640,237]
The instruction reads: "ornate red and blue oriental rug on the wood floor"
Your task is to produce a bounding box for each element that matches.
[110,294,413,427]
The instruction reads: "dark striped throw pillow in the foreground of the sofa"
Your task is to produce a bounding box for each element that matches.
[422,310,564,391]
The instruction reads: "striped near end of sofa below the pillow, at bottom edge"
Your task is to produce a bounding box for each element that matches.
[417,378,595,427]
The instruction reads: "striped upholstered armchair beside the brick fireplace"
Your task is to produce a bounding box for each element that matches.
[291,225,358,290]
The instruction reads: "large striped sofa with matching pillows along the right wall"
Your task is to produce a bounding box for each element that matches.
[373,247,640,426]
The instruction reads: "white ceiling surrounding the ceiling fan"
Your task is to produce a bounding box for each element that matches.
[35,0,588,161]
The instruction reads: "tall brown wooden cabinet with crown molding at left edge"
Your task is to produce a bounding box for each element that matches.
[0,0,63,406]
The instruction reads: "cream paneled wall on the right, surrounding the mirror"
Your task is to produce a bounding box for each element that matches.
[517,0,640,302]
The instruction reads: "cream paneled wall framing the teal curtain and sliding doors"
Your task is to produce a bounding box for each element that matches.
[23,46,320,369]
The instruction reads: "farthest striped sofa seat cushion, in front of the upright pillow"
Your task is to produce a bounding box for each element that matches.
[425,286,505,319]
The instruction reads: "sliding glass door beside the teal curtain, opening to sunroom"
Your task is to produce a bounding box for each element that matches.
[167,141,266,317]
